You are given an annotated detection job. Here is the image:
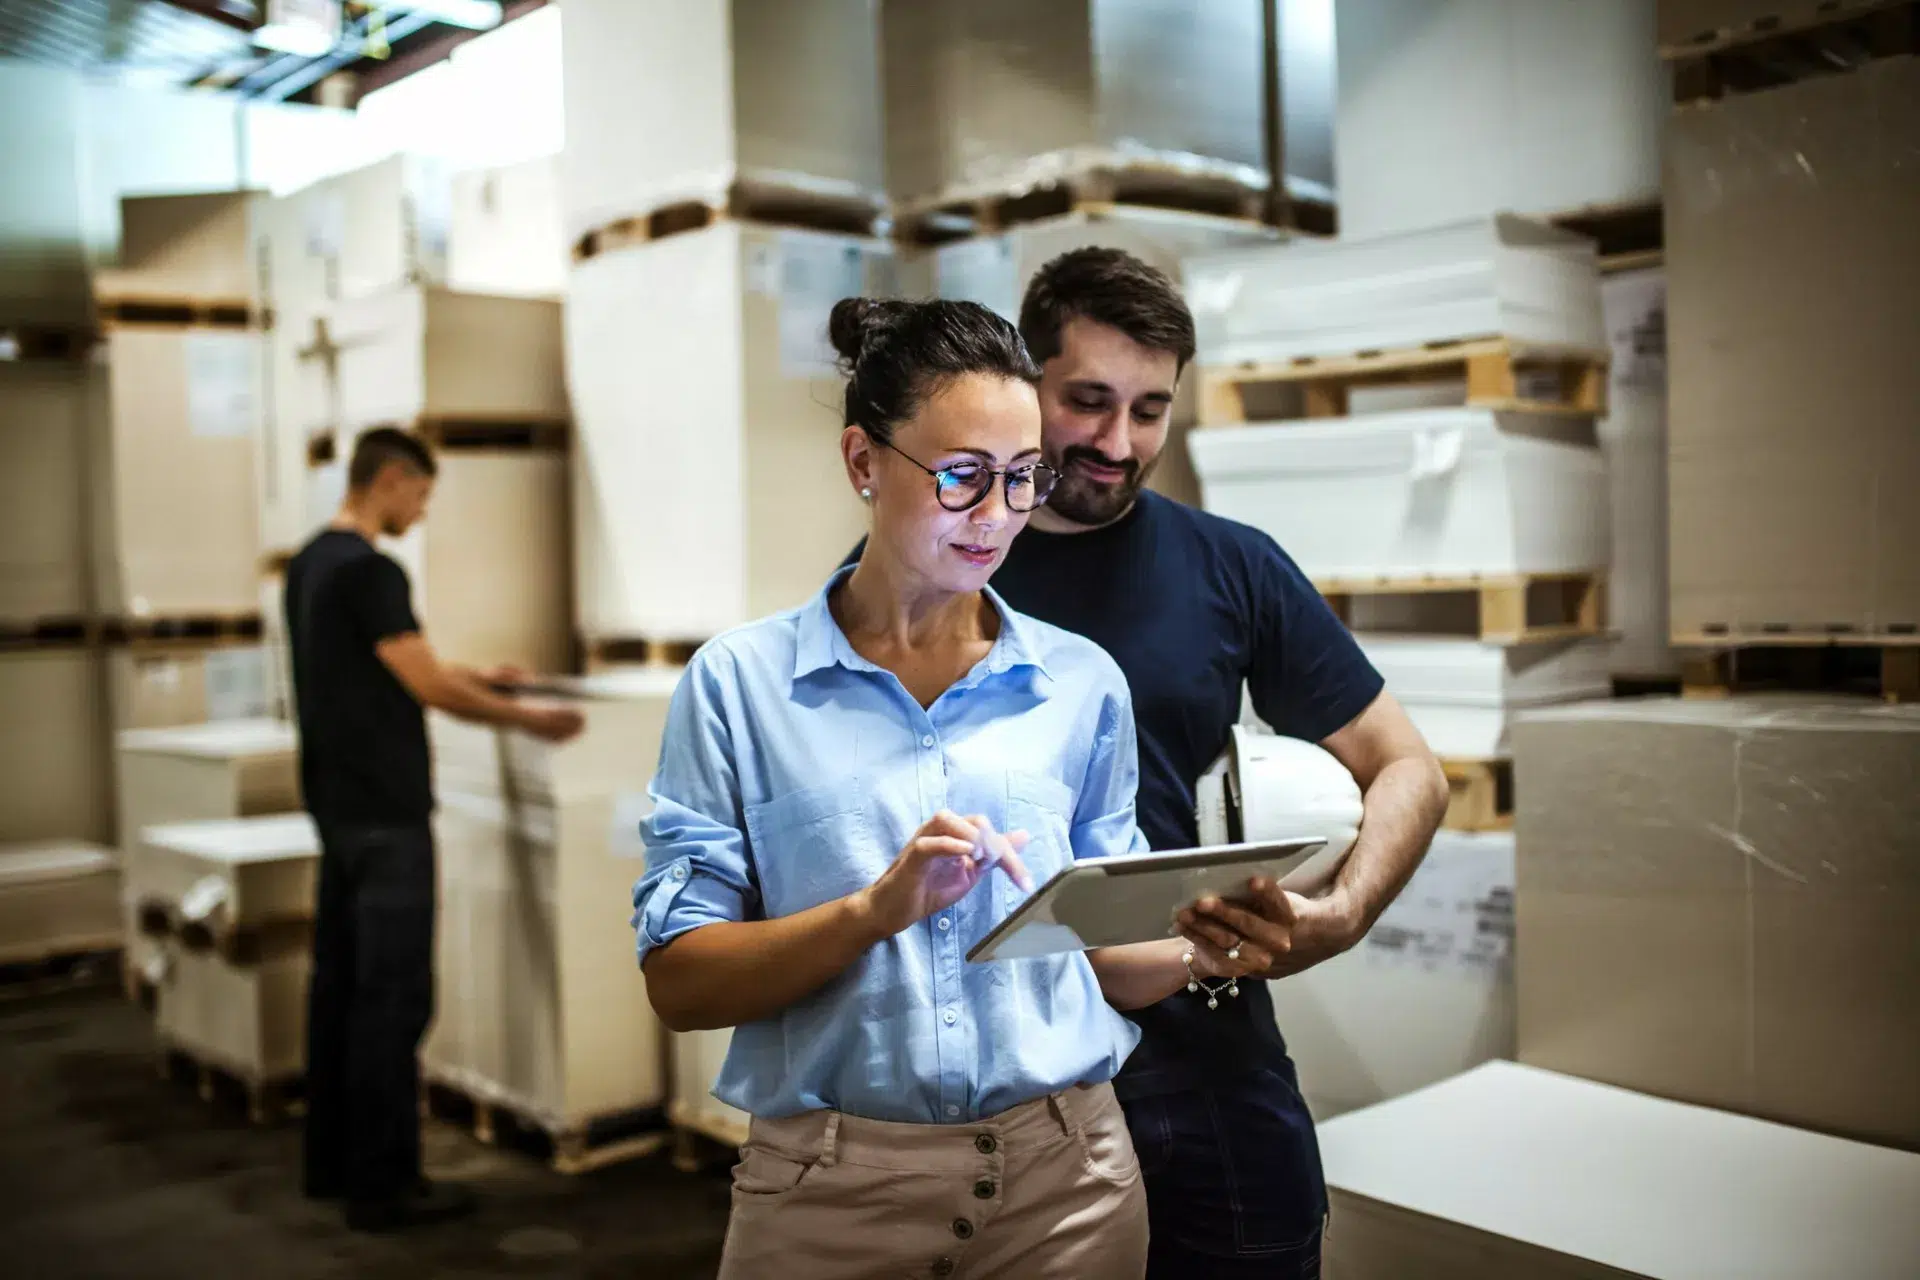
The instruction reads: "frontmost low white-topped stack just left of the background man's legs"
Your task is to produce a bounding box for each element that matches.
[140,814,321,1084]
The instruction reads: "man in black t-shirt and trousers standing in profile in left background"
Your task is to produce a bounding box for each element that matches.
[286,428,582,1230]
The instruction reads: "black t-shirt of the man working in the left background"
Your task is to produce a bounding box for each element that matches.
[286,530,434,827]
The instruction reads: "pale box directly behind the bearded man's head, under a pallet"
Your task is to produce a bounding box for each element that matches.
[900,207,1279,507]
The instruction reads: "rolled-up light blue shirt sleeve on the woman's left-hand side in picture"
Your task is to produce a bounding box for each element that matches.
[632,651,760,963]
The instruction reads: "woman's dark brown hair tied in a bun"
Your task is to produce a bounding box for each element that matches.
[828,297,1041,443]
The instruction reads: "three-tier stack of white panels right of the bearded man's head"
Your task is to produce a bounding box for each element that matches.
[1187,215,1611,782]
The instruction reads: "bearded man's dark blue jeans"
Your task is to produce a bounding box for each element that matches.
[1123,1063,1327,1280]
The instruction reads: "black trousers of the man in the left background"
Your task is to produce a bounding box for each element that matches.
[305,821,434,1201]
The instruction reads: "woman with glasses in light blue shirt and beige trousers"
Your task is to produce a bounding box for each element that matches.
[634,299,1271,1280]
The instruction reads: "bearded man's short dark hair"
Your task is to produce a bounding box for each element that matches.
[1020,248,1194,368]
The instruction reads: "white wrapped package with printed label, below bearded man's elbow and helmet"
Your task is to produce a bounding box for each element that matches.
[1267,831,1513,1121]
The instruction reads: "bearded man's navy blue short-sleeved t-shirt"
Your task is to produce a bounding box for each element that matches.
[848,491,1382,1098]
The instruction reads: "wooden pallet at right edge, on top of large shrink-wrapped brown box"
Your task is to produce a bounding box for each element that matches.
[1674,631,1920,702]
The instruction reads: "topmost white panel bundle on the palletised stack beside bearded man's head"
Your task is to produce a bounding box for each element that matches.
[1185,215,1607,365]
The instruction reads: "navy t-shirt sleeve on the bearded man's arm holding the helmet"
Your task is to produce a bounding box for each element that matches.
[1246,535,1386,743]
